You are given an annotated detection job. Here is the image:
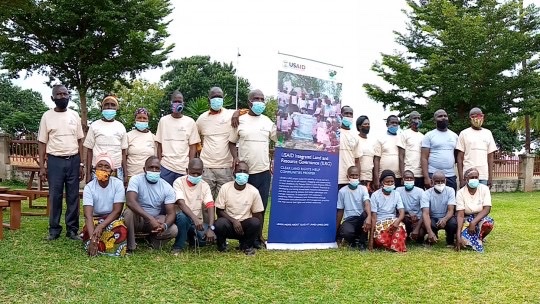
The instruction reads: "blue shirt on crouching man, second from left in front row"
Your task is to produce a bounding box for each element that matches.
[127,173,176,217]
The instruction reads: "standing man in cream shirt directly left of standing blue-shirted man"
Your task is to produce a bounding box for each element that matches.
[397,111,424,189]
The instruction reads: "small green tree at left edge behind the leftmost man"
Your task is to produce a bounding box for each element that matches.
[0,75,49,137]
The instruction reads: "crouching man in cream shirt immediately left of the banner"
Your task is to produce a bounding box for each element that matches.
[214,161,264,255]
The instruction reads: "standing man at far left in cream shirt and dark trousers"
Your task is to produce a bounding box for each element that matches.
[38,85,84,241]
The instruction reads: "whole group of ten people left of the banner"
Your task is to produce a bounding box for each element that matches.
[38,85,276,256]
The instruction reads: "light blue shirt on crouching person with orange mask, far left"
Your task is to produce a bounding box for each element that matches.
[83,177,126,216]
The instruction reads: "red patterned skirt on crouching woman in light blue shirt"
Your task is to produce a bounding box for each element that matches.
[373,218,407,252]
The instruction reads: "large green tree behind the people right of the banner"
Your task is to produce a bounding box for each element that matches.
[364,0,540,151]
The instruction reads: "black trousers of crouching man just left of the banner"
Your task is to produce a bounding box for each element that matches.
[214,217,261,249]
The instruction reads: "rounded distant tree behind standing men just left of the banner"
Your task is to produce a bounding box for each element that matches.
[161,56,249,111]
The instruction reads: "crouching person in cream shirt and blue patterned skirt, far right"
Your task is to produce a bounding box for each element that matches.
[456,168,494,252]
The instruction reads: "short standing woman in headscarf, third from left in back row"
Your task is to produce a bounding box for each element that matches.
[127,108,157,179]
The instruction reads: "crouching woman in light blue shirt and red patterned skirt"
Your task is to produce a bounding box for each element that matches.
[369,170,407,252]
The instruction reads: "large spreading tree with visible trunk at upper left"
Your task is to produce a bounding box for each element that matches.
[0,0,174,129]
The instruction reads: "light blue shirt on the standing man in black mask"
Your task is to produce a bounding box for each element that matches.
[422,129,458,177]
